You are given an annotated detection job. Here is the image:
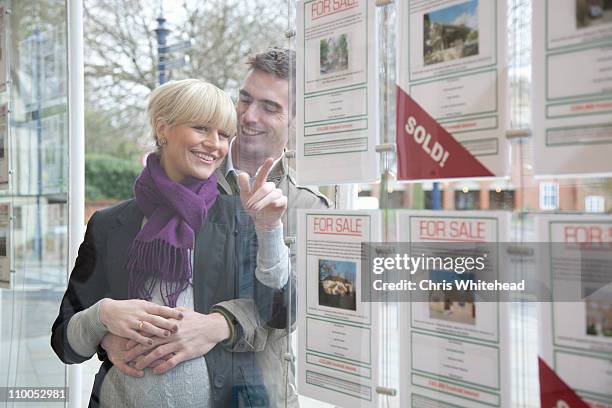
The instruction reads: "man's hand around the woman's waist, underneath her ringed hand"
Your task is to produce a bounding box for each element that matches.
[124,307,230,374]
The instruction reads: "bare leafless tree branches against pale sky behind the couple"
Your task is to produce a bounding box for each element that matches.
[84,0,288,153]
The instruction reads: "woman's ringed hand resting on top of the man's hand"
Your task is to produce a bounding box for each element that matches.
[100,298,183,345]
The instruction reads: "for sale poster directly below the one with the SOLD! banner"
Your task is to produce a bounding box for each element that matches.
[398,211,511,408]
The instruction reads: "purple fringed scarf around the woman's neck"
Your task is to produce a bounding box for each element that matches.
[126,154,219,307]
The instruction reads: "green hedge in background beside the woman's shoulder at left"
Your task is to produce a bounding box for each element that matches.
[85,154,141,201]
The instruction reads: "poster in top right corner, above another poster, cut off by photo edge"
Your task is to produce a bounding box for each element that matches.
[532,0,612,176]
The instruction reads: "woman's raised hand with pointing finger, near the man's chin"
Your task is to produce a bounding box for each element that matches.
[238,158,287,229]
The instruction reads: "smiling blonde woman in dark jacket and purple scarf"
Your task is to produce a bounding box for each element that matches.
[51,79,289,407]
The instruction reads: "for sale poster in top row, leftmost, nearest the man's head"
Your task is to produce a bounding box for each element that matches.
[296,0,380,185]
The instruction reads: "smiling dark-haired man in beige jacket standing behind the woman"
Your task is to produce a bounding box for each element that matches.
[216,48,330,407]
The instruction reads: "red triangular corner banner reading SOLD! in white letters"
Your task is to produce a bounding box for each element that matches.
[397,86,495,180]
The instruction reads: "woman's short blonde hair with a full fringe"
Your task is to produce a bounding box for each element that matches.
[147,79,236,146]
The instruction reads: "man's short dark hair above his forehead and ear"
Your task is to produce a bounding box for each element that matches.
[248,47,295,116]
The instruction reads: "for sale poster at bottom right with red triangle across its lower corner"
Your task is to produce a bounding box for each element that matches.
[536,215,612,408]
